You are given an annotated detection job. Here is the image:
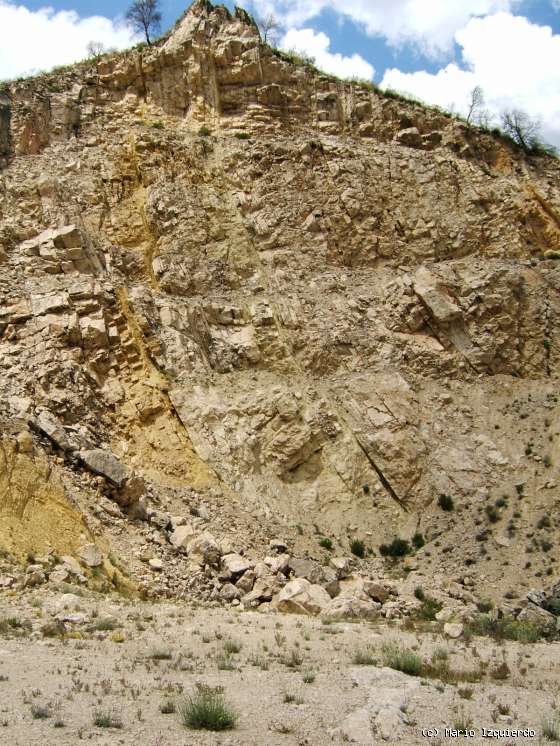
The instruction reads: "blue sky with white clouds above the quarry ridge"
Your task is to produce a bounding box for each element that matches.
[0,0,560,145]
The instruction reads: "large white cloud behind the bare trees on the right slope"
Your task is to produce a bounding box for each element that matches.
[381,13,560,145]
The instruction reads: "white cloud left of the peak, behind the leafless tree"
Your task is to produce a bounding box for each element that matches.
[0,0,133,79]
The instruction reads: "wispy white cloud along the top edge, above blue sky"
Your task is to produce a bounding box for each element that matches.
[253,0,520,56]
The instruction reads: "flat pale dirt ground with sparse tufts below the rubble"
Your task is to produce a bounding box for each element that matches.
[0,591,560,746]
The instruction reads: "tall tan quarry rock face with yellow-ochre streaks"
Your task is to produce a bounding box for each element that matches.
[0,2,560,600]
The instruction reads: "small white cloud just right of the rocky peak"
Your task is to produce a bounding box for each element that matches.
[281,28,375,80]
